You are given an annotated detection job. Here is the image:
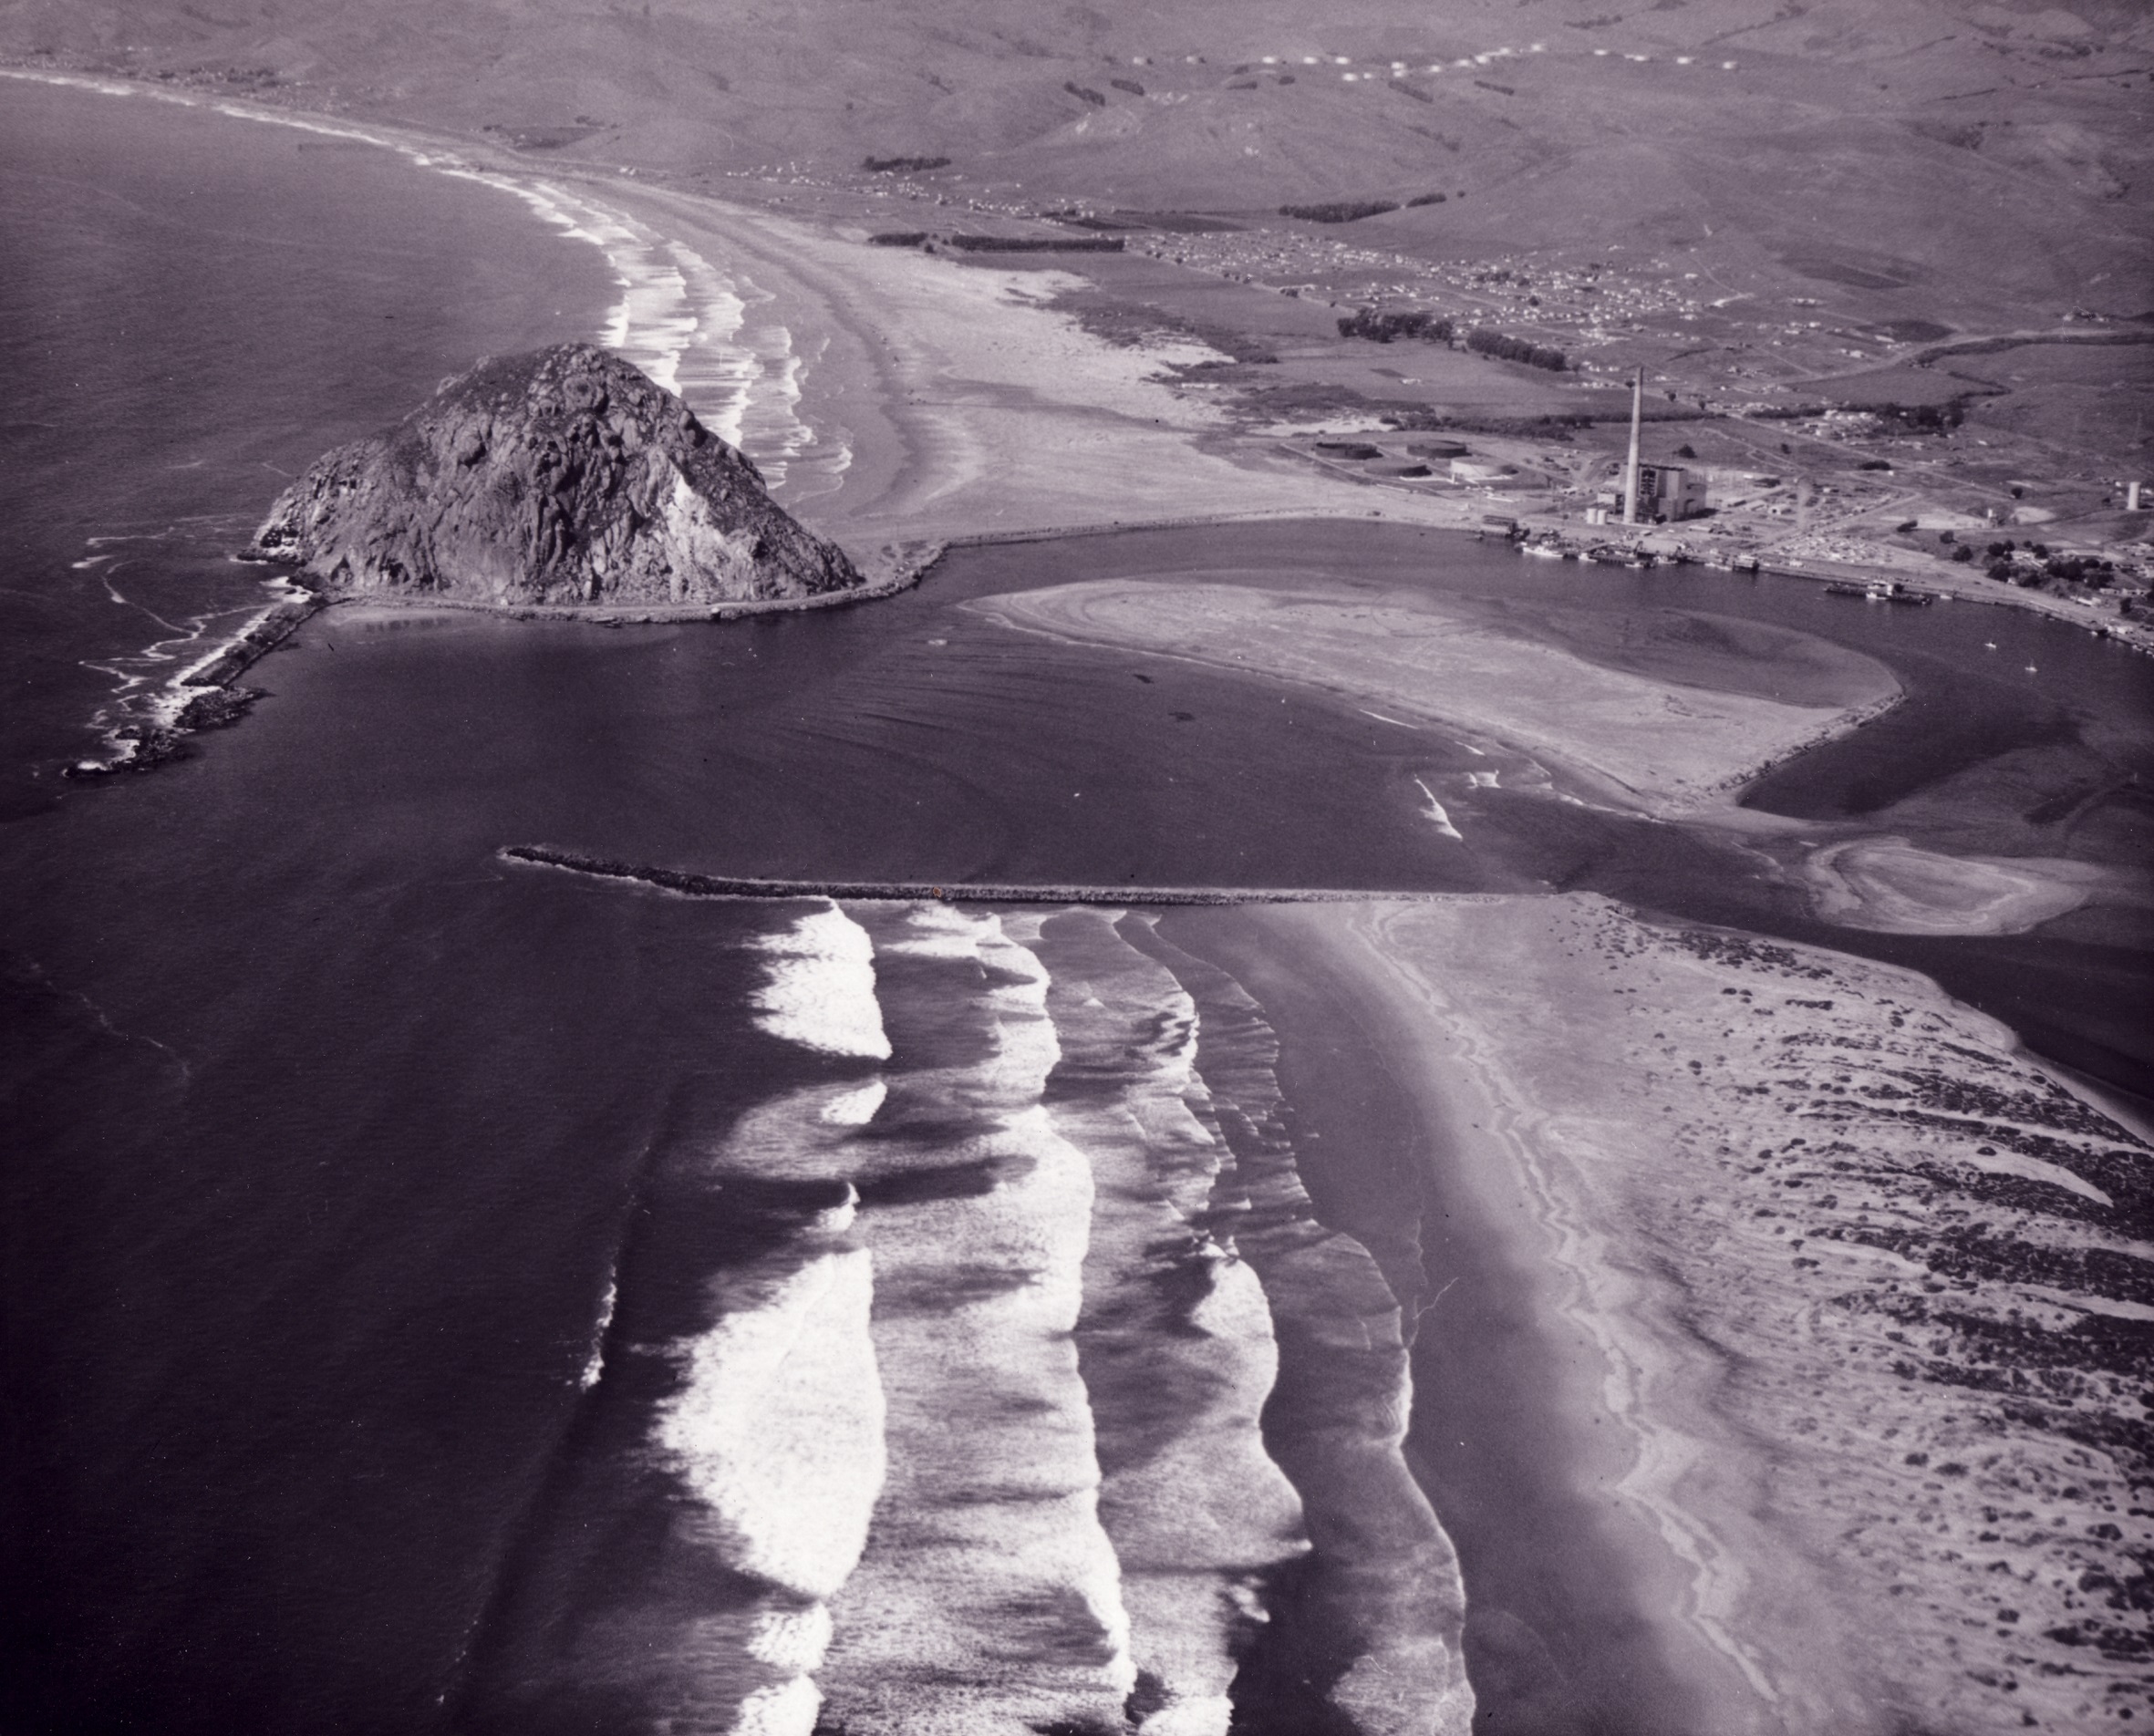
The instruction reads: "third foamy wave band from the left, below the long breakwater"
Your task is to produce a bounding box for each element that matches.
[1010,911,1308,1736]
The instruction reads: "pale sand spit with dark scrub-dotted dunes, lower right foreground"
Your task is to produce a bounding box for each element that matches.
[1258,896,2154,1736]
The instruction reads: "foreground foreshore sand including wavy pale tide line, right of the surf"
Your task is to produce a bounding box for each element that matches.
[1197,894,1787,1736]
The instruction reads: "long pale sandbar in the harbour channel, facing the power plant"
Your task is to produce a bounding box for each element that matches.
[965,573,1898,814]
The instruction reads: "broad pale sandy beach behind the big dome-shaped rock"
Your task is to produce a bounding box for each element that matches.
[606,188,1477,545]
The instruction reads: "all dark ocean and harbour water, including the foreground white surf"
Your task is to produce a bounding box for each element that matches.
[0,84,2154,1736]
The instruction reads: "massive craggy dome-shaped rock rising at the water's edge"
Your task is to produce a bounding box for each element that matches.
[248,345,864,605]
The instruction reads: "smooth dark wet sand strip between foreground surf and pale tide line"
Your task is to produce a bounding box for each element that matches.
[1165,894,1762,1736]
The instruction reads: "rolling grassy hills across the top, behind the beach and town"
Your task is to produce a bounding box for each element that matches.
[0,0,2154,482]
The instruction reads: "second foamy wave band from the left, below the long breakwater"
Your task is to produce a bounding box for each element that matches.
[821,904,1135,1736]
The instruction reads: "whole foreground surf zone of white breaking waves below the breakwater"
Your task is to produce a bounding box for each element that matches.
[469,900,1471,1736]
